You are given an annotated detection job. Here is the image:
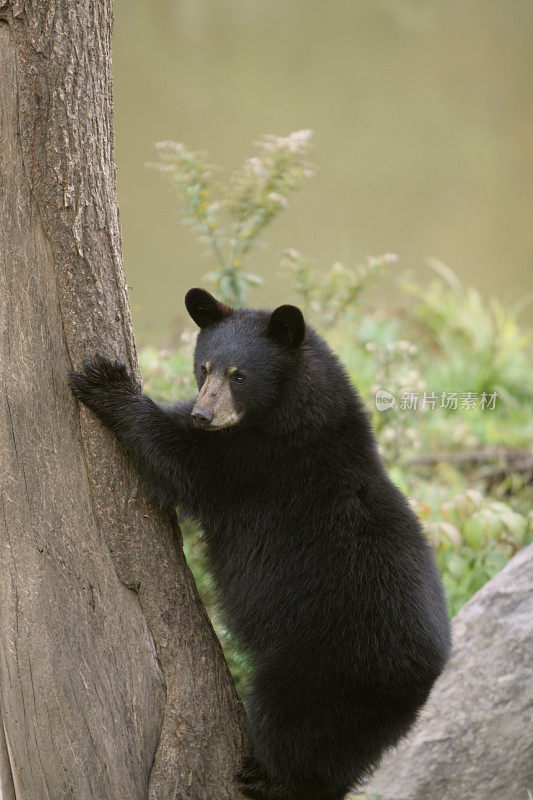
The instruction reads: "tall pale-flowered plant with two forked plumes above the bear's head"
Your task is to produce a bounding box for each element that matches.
[148,130,314,305]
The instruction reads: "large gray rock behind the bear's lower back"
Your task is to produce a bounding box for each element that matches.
[366,545,533,800]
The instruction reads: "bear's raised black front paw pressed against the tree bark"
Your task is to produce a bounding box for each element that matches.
[69,353,141,421]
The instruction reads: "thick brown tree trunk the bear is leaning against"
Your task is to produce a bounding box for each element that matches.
[0,0,244,800]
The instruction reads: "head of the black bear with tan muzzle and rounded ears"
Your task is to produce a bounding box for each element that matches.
[185,289,306,431]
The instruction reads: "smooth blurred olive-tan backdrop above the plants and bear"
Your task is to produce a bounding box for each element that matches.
[114,0,533,344]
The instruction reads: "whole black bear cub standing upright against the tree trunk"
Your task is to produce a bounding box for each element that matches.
[70,289,450,800]
